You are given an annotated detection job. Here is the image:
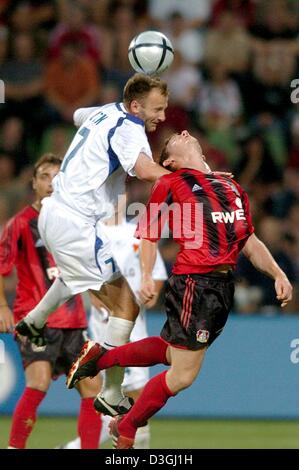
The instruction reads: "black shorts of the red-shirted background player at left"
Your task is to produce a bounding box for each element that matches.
[16,326,87,378]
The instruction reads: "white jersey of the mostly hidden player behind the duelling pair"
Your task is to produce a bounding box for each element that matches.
[105,221,167,295]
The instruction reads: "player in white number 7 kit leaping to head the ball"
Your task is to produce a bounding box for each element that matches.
[16,74,168,415]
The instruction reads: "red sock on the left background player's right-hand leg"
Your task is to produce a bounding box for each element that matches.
[78,398,102,449]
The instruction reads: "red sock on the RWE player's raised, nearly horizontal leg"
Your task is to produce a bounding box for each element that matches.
[97,336,168,370]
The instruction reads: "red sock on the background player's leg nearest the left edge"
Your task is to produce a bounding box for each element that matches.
[9,387,46,449]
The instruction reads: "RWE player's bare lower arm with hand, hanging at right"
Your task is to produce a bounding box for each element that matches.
[243,233,293,307]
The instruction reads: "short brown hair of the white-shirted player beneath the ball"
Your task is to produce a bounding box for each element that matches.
[123,73,168,105]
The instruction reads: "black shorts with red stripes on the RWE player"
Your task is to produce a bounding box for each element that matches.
[161,272,235,350]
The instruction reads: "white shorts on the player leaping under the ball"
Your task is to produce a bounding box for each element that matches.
[38,197,121,294]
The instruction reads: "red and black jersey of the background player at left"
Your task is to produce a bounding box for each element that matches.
[0,206,87,328]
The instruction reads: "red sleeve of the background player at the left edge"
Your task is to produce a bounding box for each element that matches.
[0,218,20,276]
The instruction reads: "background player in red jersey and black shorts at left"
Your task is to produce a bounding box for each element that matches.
[0,154,101,449]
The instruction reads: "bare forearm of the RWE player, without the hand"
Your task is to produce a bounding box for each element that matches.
[243,233,284,279]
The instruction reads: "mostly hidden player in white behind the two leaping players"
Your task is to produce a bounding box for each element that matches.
[63,214,167,449]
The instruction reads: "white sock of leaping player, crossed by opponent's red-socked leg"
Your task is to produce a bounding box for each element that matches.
[100,317,134,405]
